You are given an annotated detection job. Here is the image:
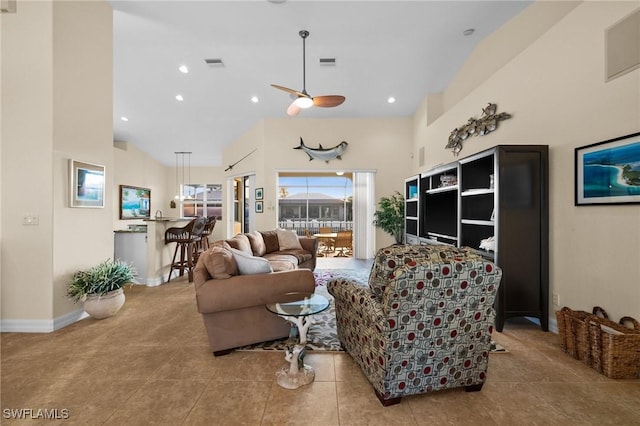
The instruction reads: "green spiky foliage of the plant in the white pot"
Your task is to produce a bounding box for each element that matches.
[67,259,137,302]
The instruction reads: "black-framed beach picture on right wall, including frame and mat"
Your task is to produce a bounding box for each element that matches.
[575,133,640,206]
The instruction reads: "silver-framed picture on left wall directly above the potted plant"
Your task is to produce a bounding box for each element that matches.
[69,160,105,208]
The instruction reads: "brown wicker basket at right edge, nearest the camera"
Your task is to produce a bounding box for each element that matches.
[588,315,640,379]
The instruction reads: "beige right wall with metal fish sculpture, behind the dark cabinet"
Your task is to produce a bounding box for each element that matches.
[414,1,640,319]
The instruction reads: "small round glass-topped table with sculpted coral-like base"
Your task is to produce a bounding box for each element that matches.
[266,293,329,389]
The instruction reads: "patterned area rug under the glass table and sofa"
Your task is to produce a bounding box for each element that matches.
[236,269,509,353]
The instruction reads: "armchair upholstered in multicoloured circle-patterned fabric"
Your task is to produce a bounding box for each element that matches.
[327,245,502,406]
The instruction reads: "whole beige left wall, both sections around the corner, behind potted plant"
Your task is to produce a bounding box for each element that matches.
[0,1,113,330]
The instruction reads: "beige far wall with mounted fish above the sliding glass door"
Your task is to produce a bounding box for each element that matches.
[223,116,412,247]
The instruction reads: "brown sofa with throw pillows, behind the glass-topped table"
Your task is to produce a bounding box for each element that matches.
[194,231,318,356]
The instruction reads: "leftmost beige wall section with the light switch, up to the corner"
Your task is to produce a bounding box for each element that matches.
[0,3,53,319]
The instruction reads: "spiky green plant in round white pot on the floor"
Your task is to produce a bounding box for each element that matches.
[67,260,137,319]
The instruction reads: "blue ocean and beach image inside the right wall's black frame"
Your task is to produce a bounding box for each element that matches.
[582,141,640,198]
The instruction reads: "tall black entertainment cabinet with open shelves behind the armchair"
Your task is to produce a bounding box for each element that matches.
[408,145,549,331]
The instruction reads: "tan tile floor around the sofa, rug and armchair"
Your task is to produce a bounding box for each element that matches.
[0,259,640,426]
